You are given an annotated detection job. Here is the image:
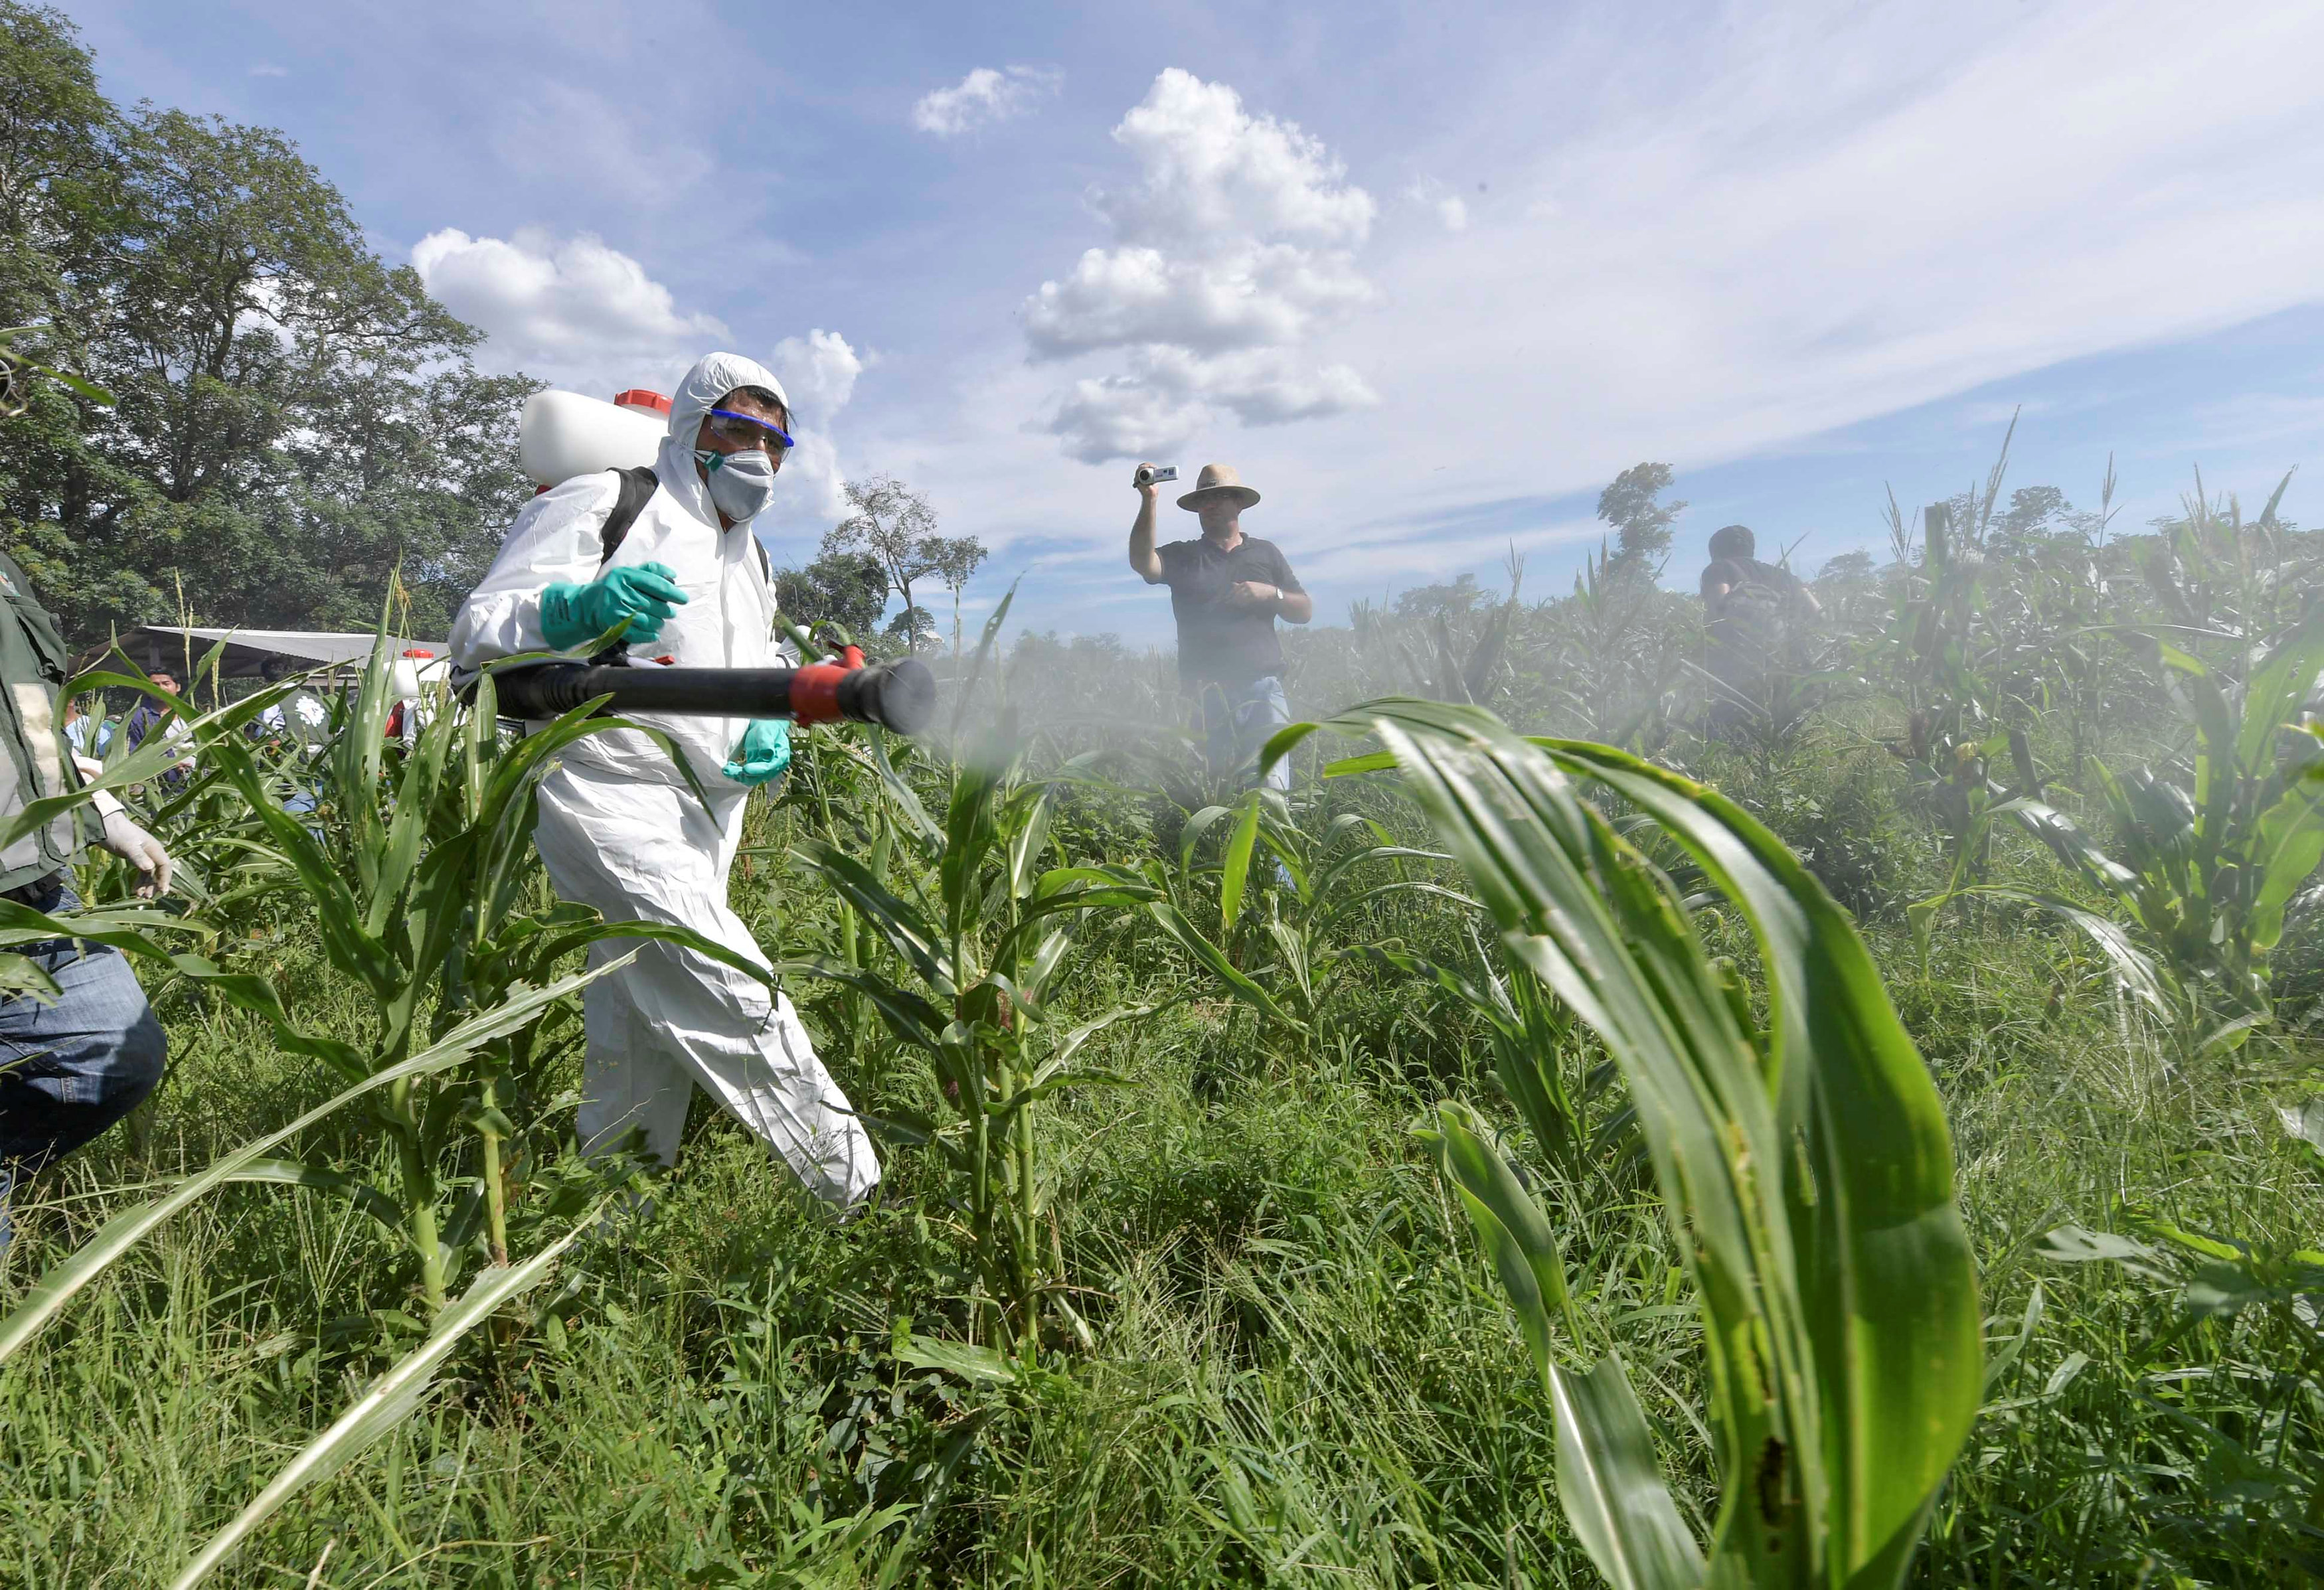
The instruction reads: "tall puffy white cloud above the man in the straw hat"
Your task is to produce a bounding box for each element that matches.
[1023,68,1378,463]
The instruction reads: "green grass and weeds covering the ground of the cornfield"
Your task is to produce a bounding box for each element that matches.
[0,490,2324,1590]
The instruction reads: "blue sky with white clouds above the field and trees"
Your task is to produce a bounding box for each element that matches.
[68,0,2324,641]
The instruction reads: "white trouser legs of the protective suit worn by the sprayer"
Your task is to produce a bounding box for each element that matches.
[535,765,878,1209]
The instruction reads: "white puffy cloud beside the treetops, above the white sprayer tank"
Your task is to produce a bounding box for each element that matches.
[412,228,728,395]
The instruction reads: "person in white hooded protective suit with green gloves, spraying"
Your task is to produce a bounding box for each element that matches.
[451,353,878,1211]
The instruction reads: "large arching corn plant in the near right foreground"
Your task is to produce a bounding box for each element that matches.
[1269,700,1983,1590]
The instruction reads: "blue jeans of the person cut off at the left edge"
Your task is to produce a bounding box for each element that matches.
[0,881,167,1248]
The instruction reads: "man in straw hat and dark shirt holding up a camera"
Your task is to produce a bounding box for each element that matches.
[1129,465,1315,790]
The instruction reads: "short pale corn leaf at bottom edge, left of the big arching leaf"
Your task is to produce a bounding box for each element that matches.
[1550,1353,1720,1590]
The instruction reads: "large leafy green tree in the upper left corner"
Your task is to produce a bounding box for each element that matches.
[0,0,533,644]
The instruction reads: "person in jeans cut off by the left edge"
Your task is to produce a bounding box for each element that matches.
[0,553,170,1248]
